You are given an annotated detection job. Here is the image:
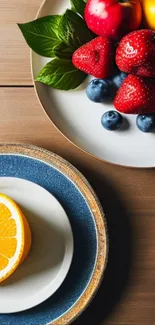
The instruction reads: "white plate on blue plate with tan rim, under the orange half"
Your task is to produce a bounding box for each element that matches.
[0,144,107,325]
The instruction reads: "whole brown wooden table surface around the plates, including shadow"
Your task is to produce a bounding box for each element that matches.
[0,0,155,325]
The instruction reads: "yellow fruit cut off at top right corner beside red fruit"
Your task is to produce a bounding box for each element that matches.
[141,0,155,30]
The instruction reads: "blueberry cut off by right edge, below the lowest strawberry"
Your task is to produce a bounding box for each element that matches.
[136,113,155,132]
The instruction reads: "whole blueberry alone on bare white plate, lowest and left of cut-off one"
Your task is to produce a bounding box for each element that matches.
[101,111,123,131]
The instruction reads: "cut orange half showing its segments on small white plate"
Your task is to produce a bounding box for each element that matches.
[0,193,31,282]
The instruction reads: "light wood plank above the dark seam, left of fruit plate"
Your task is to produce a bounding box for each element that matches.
[0,0,42,85]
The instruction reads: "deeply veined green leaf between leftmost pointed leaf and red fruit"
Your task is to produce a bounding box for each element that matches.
[59,9,94,51]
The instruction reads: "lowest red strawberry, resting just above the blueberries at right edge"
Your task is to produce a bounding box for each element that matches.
[114,74,155,114]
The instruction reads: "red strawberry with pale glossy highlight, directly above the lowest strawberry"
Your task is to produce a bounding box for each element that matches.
[116,29,155,78]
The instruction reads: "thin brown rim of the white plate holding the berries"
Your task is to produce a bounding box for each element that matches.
[30,0,155,170]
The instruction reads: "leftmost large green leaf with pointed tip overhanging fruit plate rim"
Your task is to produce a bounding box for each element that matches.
[18,15,61,57]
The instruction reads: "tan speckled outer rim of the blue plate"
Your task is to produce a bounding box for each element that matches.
[0,142,109,325]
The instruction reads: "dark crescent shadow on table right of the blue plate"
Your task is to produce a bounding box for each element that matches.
[72,166,132,325]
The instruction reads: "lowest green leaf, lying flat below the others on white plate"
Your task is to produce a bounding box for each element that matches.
[36,59,87,90]
